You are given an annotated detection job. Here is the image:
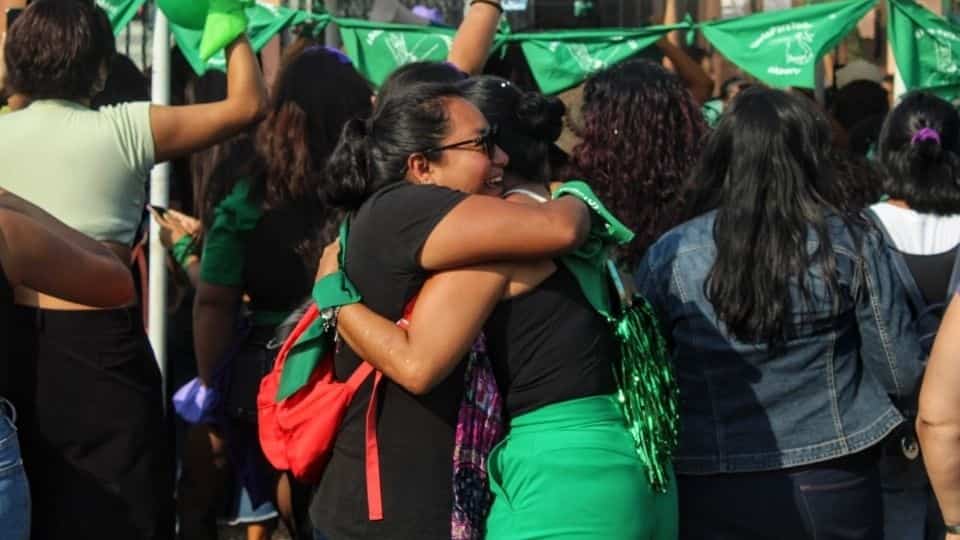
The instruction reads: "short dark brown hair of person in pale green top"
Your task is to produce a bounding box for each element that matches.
[4,0,116,100]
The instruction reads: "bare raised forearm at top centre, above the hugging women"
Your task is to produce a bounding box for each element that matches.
[447,0,502,75]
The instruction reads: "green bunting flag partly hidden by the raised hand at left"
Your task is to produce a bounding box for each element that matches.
[170,3,316,75]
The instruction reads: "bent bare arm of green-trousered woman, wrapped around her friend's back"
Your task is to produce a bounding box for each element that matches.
[337,265,508,394]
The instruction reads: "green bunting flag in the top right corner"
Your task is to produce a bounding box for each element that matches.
[889,0,960,99]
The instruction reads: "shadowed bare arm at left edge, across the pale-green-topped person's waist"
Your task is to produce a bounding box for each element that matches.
[0,207,136,307]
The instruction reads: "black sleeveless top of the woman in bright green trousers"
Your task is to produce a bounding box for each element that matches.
[484,263,620,418]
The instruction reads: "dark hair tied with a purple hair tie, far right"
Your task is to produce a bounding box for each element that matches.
[879,92,960,215]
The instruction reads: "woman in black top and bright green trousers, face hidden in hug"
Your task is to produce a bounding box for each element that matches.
[321,77,677,539]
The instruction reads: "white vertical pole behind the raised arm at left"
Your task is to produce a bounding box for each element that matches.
[148,8,170,403]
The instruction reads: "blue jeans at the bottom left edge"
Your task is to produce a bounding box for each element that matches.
[0,398,30,540]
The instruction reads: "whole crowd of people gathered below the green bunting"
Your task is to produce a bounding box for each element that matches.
[0,0,960,540]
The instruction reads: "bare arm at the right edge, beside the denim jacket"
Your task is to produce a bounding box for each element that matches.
[917,295,960,539]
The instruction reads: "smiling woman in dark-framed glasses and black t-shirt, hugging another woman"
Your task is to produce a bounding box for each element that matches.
[310,85,589,540]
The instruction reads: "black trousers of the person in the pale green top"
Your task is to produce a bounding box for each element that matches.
[13,308,173,540]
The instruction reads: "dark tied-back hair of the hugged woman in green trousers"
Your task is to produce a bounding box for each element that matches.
[460,76,566,183]
